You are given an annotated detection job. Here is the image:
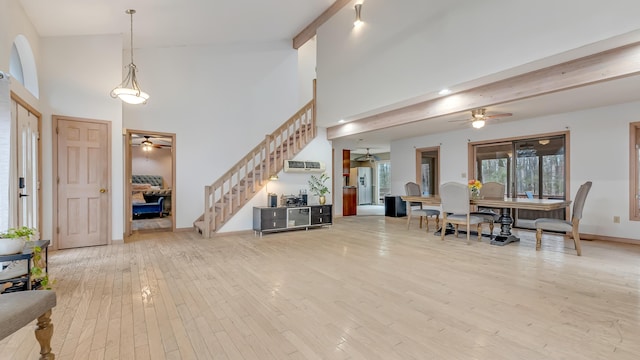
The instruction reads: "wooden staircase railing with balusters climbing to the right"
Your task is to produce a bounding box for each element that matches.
[193,96,316,238]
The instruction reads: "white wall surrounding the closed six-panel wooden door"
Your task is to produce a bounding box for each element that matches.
[38,35,124,240]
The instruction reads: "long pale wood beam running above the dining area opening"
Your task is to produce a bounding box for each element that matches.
[327,43,640,139]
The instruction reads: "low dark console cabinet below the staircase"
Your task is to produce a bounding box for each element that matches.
[253,205,333,235]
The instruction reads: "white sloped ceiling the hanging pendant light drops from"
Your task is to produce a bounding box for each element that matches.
[20,0,334,48]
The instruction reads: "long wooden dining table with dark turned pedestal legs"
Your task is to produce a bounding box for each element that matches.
[401,195,571,246]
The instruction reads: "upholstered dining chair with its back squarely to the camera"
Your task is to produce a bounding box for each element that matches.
[440,182,484,244]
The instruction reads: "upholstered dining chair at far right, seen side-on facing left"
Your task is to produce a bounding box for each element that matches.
[535,181,591,256]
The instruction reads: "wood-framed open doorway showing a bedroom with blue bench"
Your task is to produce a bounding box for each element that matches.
[124,129,176,236]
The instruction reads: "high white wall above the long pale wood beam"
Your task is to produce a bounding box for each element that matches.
[317,0,640,124]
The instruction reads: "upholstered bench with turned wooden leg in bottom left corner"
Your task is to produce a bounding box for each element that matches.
[0,290,56,360]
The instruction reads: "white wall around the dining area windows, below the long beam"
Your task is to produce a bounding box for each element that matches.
[391,102,640,243]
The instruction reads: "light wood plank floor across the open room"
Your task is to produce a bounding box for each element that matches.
[0,216,640,360]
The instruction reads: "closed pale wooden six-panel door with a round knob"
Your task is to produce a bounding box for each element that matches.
[54,117,111,249]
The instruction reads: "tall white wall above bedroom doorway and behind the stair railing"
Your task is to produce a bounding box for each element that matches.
[124,41,311,229]
